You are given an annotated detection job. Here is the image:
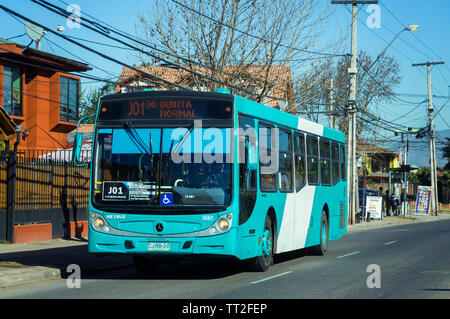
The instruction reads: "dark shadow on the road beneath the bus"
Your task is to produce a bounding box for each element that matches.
[0,245,308,280]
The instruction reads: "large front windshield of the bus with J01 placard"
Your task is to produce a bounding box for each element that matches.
[93,123,231,208]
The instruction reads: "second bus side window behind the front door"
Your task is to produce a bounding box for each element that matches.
[278,130,294,192]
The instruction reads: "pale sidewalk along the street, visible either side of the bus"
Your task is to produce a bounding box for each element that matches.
[0,213,450,294]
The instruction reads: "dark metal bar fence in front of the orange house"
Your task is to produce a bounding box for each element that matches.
[0,150,90,242]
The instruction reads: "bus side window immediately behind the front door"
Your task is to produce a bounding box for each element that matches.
[258,124,278,192]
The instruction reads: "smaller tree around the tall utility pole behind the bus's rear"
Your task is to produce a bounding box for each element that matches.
[297,51,401,142]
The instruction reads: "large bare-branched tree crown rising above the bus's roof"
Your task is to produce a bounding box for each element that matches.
[138,0,338,107]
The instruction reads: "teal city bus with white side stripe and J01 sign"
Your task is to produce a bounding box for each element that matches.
[80,89,347,271]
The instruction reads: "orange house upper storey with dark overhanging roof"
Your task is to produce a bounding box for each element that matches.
[0,39,91,150]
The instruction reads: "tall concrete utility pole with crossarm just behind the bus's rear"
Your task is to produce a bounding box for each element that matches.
[331,0,378,224]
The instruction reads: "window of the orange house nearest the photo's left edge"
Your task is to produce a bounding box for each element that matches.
[3,66,22,116]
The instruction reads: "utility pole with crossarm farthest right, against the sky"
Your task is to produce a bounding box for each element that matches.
[412,61,444,216]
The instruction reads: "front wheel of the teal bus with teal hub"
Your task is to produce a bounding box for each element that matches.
[249,215,274,272]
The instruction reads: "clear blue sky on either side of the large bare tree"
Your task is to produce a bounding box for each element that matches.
[0,0,450,166]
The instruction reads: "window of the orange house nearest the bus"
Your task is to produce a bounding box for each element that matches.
[59,76,79,123]
